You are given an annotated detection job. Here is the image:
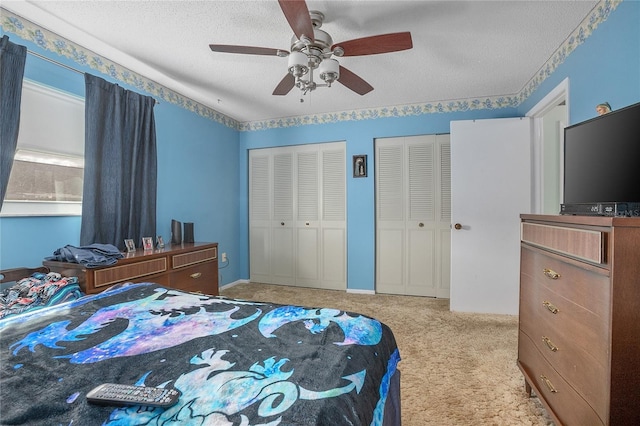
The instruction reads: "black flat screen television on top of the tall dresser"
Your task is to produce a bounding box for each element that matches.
[560,103,640,216]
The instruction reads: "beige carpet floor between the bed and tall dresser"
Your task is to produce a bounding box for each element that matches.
[221,283,553,426]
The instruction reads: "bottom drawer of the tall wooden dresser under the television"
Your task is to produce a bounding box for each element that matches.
[518,332,604,426]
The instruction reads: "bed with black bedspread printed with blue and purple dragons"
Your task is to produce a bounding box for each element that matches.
[0,283,401,426]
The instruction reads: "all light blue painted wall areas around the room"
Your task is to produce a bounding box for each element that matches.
[0,0,640,290]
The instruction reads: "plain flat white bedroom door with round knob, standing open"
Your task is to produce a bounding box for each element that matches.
[450,117,532,315]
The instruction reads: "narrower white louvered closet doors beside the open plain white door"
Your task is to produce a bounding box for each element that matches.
[376,135,450,298]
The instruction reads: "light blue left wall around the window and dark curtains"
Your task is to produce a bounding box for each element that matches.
[0,34,240,284]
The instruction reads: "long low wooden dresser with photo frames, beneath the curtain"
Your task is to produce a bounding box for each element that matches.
[42,243,218,296]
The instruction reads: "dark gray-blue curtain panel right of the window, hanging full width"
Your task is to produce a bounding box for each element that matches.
[80,74,157,249]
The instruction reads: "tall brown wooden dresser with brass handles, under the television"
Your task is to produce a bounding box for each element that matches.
[518,215,640,426]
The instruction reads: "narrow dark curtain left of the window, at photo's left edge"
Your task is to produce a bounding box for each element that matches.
[0,35,27,208]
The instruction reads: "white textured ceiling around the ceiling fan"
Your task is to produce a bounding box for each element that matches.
[2,0,598,122]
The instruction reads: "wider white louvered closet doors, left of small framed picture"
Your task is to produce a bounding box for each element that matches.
[249,142,347,290]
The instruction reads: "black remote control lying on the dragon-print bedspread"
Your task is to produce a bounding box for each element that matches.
[87,383,180,408]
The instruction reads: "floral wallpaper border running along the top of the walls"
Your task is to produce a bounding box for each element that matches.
[0,0,622,131]
